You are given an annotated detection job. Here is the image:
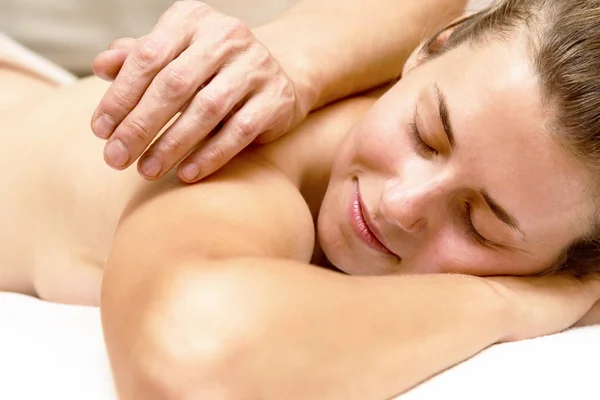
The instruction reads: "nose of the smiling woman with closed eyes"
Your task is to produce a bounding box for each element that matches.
[380,175,451,232]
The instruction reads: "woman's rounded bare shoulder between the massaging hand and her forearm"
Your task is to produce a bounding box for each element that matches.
[109,154,314,270]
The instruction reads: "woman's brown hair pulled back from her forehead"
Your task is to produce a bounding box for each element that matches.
[422,0,600,275]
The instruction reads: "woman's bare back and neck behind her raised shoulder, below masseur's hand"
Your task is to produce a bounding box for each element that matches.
[0,78,373,304]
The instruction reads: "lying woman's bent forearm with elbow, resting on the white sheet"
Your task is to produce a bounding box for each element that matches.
[102,258,514,400]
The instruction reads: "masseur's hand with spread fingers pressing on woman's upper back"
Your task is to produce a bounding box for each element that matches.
[92,1,309,182]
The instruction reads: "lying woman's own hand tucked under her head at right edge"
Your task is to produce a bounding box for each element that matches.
[486,275,600,341]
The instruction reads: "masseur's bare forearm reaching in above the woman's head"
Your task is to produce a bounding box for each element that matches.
[254,0,467,109]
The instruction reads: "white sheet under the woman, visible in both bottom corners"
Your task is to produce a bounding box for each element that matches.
[0,293,600,400]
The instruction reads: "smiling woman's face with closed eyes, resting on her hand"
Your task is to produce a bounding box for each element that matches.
[319,39,593,276]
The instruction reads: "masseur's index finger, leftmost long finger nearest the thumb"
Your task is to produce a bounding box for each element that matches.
[92,3,199,143]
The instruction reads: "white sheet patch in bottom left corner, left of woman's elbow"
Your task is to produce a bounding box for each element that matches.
[0,293,116,400]
